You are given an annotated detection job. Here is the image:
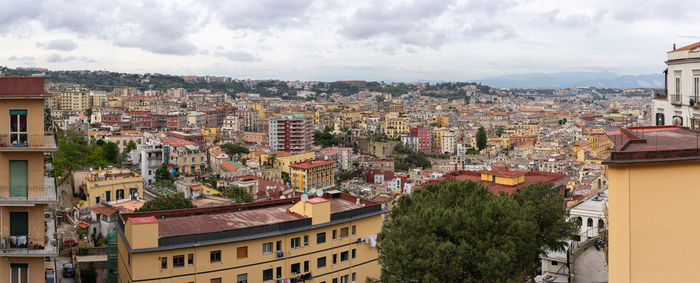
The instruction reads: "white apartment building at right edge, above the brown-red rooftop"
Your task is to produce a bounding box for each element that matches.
[651,42,700,129]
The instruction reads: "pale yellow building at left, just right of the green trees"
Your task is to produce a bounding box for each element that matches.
[85,168,143,206]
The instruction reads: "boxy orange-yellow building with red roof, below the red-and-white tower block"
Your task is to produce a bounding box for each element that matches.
[289,160,335,191]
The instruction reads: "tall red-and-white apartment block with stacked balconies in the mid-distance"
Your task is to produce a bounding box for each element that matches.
[267,114,314,153]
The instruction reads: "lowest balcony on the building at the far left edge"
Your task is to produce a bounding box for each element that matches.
[0,211,61,257]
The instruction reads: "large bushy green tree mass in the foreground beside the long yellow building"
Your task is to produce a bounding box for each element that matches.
[378,181,578,282]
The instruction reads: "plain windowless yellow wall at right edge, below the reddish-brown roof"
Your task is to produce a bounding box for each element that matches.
[607,162,700,283]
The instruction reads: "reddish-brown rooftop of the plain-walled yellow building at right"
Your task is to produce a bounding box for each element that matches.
[603,126,700,166]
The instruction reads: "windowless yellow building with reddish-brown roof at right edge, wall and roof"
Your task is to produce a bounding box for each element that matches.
[604,126,700,283]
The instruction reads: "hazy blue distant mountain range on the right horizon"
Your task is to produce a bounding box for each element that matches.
[475,72,664,88]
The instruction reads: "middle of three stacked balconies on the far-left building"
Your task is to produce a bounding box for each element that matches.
[0,176,58,205]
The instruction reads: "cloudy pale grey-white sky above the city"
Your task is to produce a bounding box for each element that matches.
[0,0,700,81]
